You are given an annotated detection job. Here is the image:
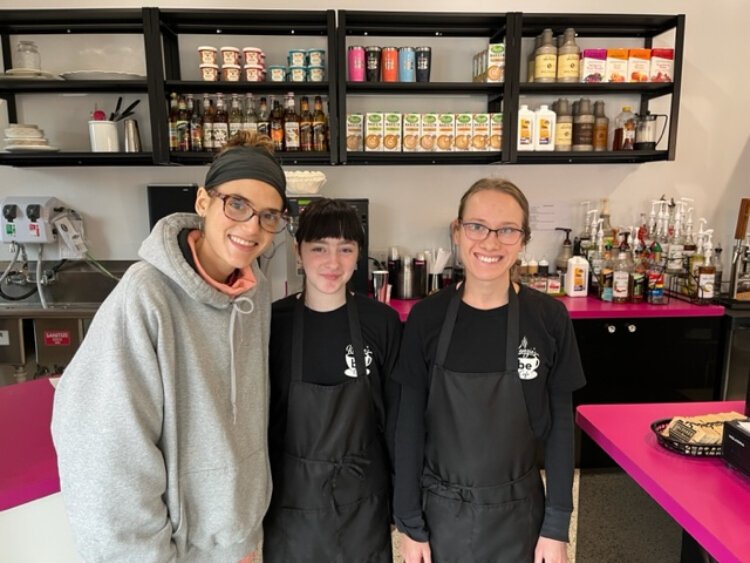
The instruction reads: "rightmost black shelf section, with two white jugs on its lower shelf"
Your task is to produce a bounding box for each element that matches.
[516,13,685,164]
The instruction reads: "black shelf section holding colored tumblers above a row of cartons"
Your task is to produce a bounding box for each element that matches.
[337,10,512,164]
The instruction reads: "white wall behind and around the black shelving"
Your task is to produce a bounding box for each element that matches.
[0,0,750,296]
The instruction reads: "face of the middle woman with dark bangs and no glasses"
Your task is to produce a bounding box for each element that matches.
[299,237,359,305]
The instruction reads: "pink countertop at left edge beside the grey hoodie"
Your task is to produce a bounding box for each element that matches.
[0,378,60,510]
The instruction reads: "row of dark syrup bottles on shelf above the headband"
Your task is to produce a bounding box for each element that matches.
[169,91,330,165]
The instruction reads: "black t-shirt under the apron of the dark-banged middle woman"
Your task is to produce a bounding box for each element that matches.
[269,295,401,460]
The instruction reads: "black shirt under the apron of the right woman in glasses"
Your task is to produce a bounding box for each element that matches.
[394,285,585,541]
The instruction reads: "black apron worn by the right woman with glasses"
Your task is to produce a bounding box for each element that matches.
[422,285,544,563]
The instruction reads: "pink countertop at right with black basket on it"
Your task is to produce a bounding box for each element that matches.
[576,401,750,563]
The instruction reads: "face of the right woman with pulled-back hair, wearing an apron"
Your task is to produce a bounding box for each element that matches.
[453,189,523,287]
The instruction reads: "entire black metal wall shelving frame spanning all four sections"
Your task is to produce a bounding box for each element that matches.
[0,8,685,166]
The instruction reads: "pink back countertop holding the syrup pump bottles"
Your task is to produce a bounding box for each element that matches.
[390,297,724,322]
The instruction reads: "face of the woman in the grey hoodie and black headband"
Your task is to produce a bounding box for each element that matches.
[195,179,283,283]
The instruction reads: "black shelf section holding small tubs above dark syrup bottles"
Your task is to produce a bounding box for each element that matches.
[156,9,339,165]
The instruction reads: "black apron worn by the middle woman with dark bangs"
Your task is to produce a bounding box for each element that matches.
[263,292,392,563]
